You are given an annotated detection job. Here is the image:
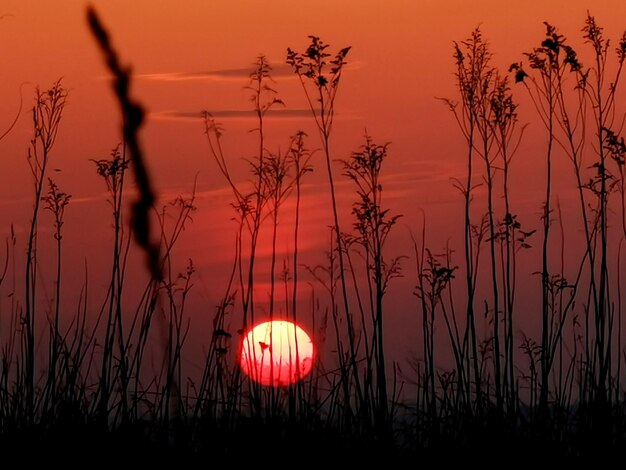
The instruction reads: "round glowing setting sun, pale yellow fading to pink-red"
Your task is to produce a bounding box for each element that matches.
[240,320,313,387]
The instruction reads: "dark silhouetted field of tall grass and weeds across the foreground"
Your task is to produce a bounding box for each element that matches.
[0,5,626,463]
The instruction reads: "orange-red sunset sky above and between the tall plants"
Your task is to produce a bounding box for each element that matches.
[0,0,626,370]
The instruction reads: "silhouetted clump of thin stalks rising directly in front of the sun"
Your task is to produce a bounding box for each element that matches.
[203,56,311,426]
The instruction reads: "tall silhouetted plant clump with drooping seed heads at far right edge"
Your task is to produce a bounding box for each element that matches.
[511,15,626,429]
